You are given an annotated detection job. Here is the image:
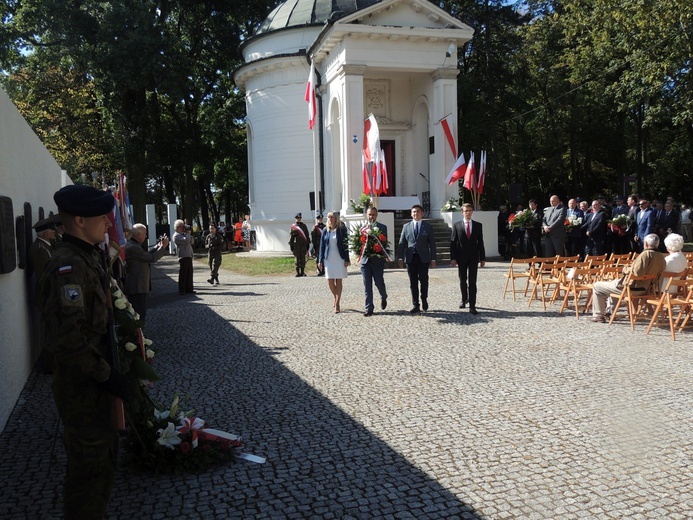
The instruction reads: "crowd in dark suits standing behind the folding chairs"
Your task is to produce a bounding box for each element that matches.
[498,194,693,258]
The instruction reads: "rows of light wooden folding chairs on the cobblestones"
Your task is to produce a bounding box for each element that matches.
[503,253,693,340]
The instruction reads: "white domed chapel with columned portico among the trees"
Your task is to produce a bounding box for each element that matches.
[234,0,473,251]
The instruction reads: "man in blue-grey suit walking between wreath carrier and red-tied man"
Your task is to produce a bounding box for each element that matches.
[397,204,436,314]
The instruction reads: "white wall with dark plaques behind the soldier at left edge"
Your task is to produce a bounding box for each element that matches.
[0,89,66,428]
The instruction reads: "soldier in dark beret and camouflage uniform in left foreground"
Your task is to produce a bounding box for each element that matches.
[37,185,128,520]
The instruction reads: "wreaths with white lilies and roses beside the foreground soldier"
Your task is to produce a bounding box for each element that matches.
[111,279,243,473]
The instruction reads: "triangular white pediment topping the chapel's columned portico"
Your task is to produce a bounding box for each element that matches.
[336,0,472,32]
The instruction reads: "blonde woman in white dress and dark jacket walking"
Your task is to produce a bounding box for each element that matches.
[318,211,351,313]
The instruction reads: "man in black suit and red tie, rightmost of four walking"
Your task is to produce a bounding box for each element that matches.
[450,204,486,314]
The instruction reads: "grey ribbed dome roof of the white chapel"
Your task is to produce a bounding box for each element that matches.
[255,0,382,36]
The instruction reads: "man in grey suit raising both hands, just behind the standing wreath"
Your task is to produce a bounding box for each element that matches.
[123,224,169,326]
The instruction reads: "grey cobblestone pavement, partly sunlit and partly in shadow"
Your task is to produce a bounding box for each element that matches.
[0,254,693,519]
